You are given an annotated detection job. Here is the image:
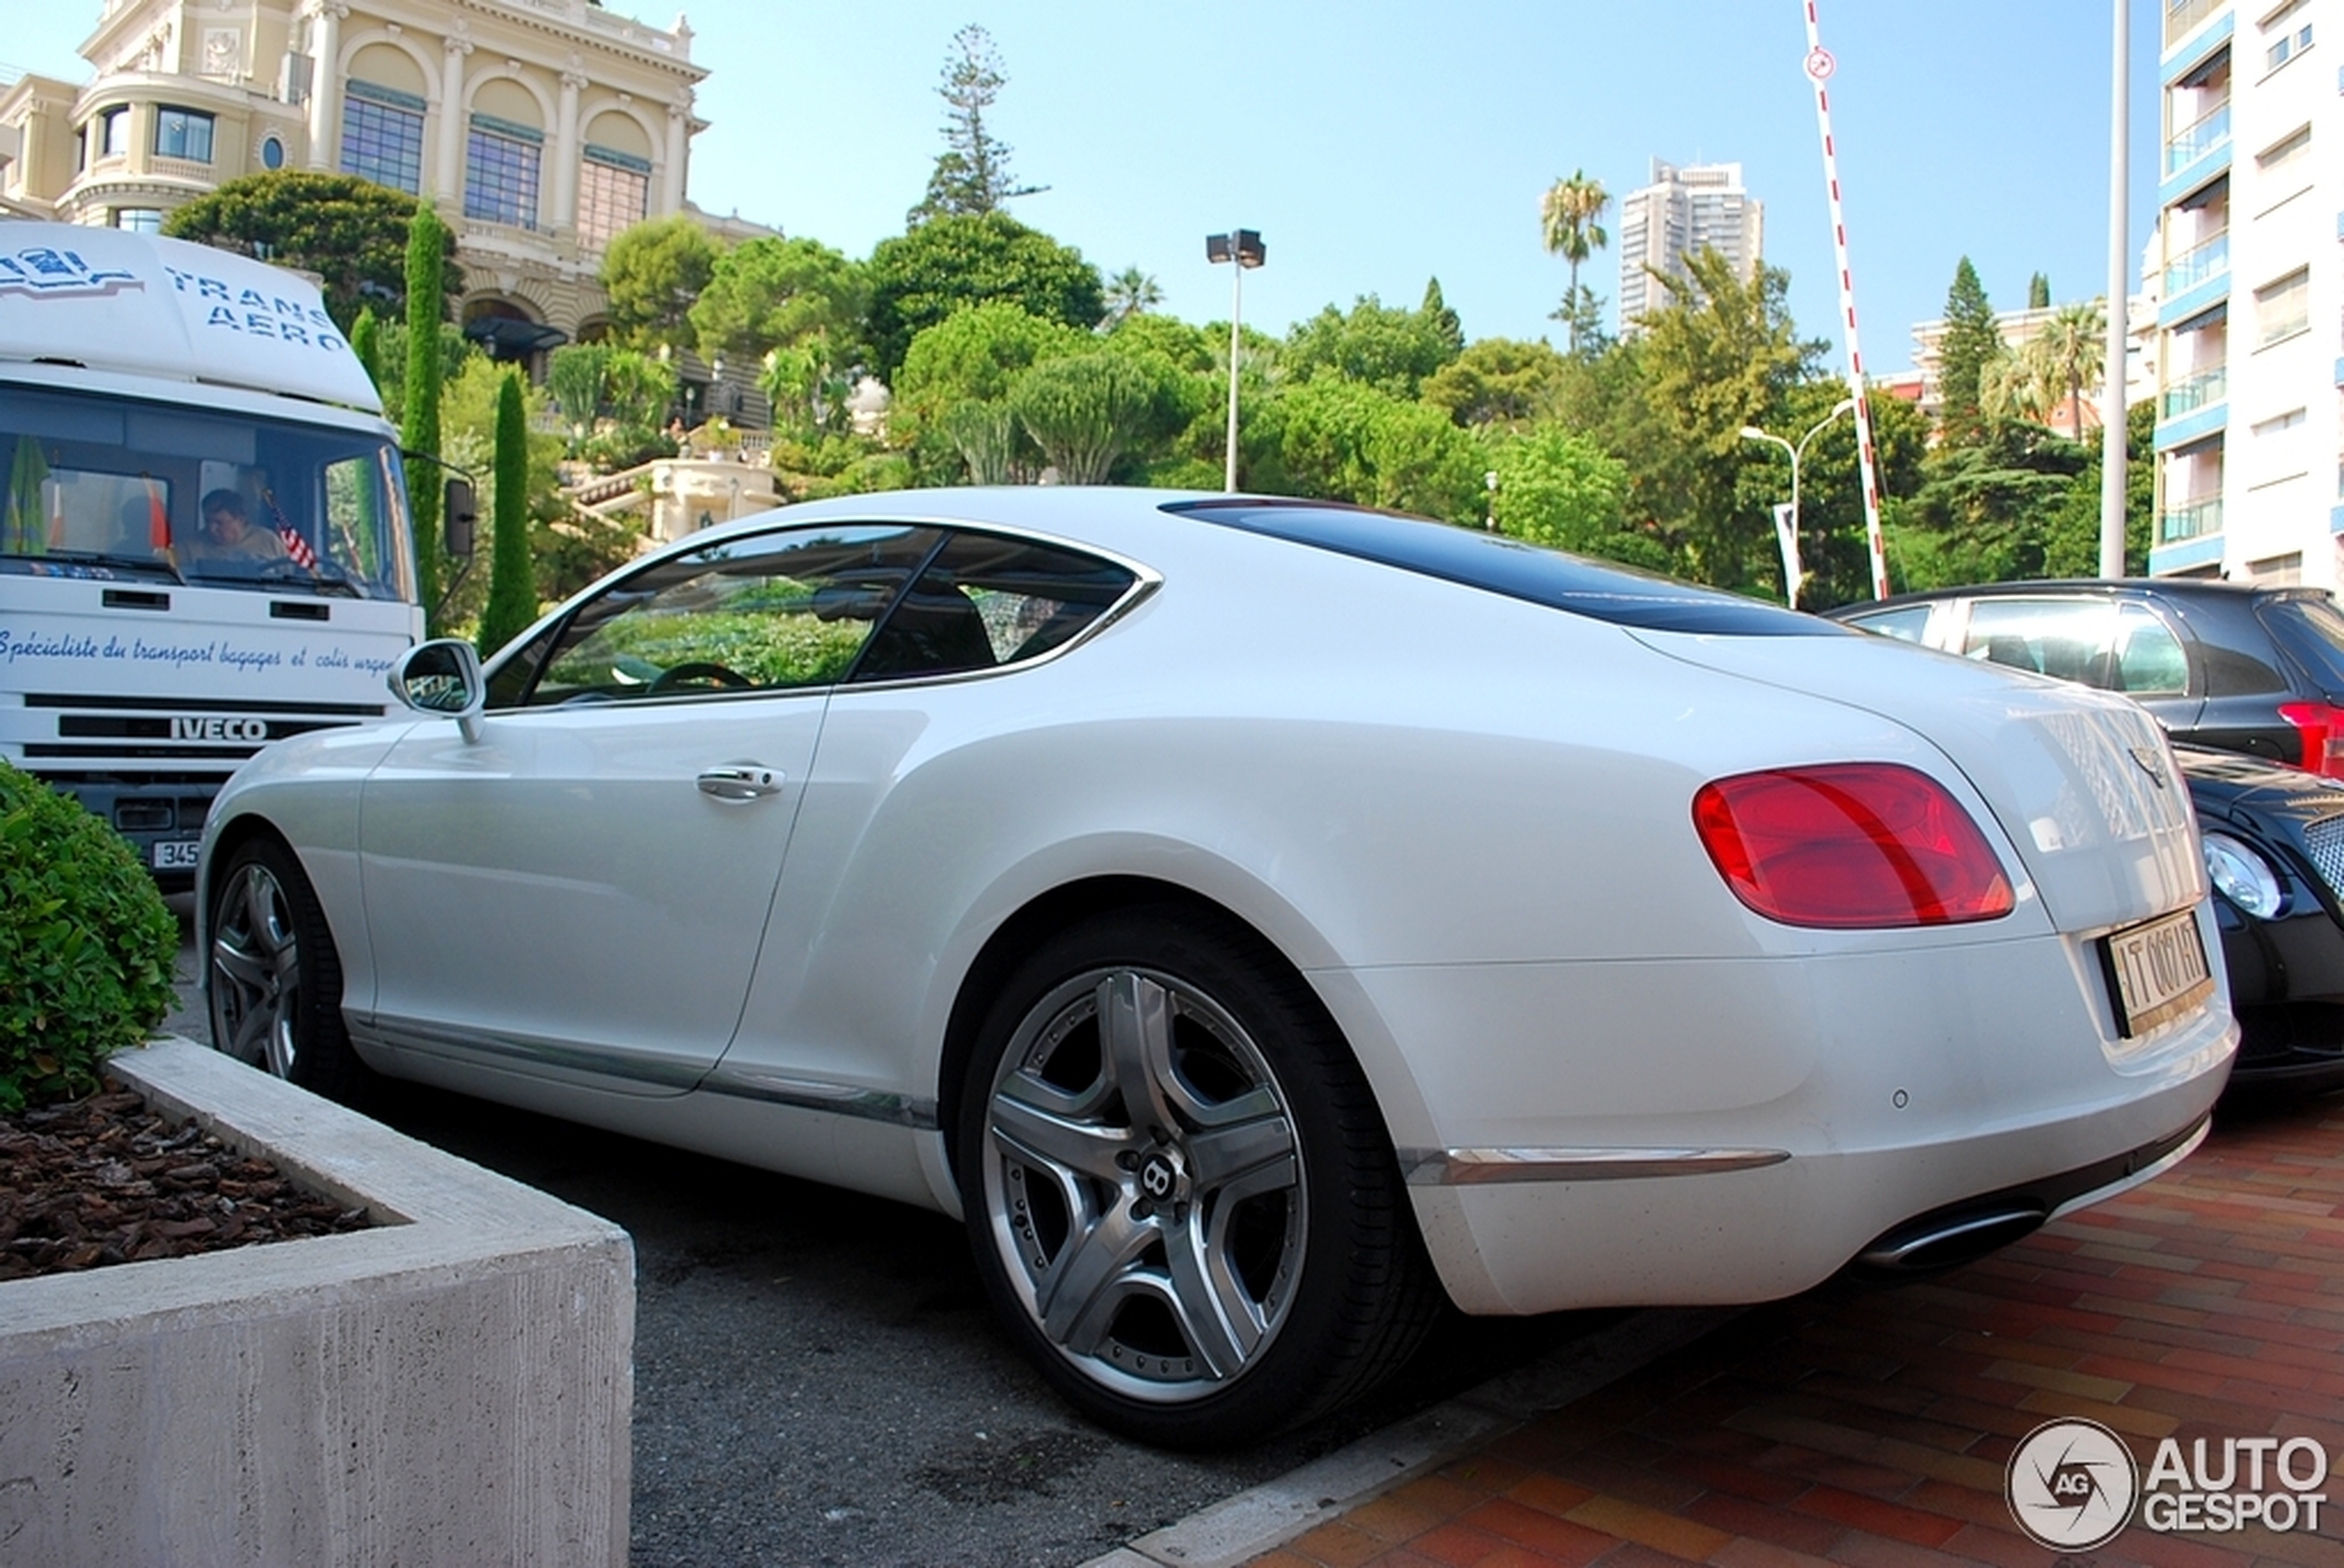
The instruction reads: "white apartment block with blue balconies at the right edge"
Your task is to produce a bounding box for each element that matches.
[2149,0,2344,588]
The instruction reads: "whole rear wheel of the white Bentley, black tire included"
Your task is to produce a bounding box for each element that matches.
[956,907,1437,1448]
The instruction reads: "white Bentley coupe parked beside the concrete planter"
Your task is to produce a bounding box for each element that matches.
[199,490,2236,1446]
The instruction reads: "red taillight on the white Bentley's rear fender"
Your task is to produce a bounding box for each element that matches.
[1692,761,2014,928]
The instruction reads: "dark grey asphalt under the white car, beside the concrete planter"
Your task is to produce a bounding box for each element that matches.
[164,898,1620,1568]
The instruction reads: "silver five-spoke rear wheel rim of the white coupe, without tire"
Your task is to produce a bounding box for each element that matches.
[980,968,1308,1404]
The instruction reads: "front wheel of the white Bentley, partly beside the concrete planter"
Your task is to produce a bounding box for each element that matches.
[209,839,368,1099]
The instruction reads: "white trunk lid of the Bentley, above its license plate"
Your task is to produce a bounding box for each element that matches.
[1632,633,2206,930]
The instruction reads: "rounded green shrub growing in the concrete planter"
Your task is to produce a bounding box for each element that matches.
[0,761,178,1113]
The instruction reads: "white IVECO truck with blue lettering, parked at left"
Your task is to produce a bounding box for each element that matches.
[0,222,472,891]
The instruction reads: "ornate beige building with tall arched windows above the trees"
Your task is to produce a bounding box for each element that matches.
[0,0,712,359]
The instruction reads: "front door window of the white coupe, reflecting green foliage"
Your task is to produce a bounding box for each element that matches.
[518,525,938,705]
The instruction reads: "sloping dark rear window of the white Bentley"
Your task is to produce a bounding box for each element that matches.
[1165,497,1859,638]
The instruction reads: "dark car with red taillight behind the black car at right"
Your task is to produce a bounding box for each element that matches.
[1831,577,2344,778]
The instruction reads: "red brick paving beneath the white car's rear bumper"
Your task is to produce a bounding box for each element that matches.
[1251,1099,2344,1568]
